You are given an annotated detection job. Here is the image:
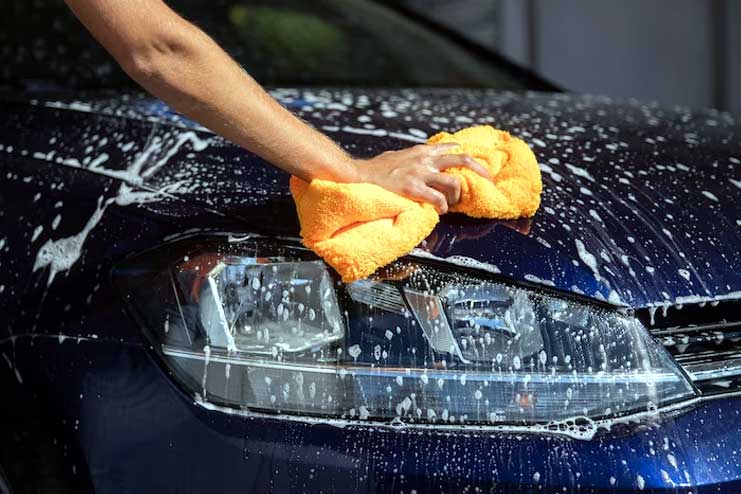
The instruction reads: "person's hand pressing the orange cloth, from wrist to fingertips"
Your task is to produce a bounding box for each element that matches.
[356,143,491,214]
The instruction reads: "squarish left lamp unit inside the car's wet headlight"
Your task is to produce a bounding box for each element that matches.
[174,254,343,356]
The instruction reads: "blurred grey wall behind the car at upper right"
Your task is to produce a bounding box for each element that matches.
[404,0,741,115]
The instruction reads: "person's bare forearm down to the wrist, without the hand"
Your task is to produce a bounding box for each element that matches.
[69,0,358,182]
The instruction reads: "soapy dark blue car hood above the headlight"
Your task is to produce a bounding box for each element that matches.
[6,89,741,307]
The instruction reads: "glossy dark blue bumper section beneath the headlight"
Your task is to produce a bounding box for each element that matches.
[4,337,741,493]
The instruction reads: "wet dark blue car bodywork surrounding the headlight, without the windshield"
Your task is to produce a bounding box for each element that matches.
[0,89,741,493]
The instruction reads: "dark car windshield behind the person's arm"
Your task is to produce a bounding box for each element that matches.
[0,0,525,90]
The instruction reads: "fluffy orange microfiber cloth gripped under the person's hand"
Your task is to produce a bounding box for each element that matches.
[291,126,543,282]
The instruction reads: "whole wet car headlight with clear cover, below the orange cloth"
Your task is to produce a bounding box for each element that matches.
[116,239,694,424]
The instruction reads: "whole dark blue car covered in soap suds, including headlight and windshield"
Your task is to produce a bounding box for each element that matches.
[0,0,741,494]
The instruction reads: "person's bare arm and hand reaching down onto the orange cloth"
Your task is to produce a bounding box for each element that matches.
[65,0,488,213]
